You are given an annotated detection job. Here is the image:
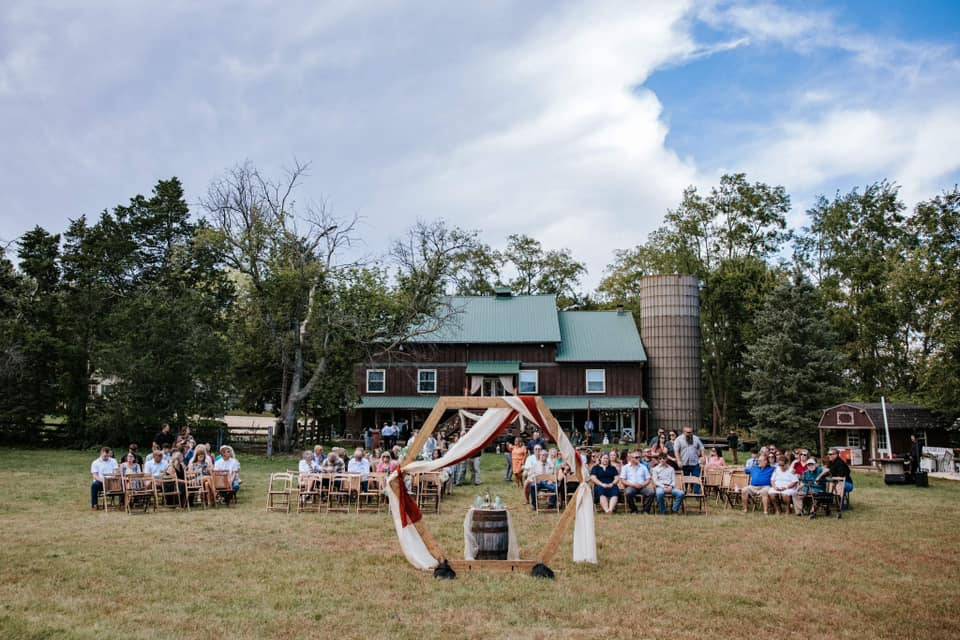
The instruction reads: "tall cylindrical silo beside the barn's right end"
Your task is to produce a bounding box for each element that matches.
[640,276,703,434]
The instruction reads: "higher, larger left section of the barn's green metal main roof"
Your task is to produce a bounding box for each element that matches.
[413,295,560,344]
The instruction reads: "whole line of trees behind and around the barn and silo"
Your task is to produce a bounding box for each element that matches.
[0,163,960,447]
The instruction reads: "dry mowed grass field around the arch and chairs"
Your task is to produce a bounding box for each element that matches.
[0,448,960,640]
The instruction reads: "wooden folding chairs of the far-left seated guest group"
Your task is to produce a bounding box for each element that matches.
[100,471,236,513]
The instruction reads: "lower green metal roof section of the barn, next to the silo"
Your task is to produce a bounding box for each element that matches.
[557,311,647,362]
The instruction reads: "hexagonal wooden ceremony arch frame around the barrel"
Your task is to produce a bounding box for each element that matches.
[391,396,587,573]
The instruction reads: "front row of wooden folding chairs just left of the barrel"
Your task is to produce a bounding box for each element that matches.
[267,471,452,513]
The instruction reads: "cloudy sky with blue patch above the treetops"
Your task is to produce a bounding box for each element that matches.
[0,0,960,286]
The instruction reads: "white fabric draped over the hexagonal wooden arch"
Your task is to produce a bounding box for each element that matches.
[384,396,597,570]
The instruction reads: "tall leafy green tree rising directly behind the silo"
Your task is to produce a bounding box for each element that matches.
[598,174,790,434]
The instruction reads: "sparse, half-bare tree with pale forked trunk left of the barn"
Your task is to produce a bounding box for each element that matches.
[203,163,476,450]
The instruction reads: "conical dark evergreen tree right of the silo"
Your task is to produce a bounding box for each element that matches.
[744,272,842,447]
